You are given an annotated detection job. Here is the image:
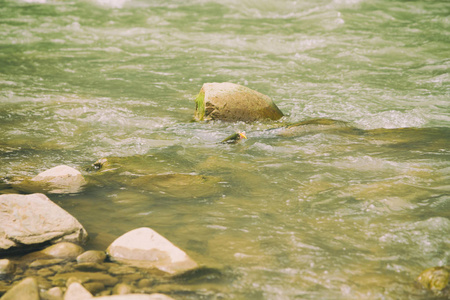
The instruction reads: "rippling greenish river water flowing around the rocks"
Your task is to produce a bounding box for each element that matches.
[0,0,450,299]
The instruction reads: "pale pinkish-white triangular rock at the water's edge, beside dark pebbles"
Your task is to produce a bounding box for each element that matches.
[106,227,198,274]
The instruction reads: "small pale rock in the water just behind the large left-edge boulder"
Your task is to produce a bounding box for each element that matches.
[31,165,86,194]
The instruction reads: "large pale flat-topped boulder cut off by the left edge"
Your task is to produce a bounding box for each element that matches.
[0,194,87,254]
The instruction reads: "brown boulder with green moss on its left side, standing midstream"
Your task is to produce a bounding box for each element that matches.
[195,82,283,122]
